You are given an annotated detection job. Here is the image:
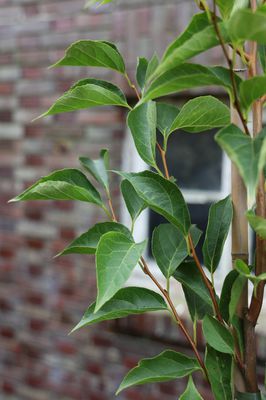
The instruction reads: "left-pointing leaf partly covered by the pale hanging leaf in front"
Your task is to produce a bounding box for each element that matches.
[58,222,133,256]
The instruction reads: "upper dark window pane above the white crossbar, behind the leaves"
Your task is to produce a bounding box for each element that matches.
[158,130,222,190]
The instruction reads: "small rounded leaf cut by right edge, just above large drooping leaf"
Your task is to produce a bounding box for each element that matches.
[240,75,266,110]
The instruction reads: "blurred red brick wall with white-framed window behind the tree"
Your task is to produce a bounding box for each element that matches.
[0,0,266,400]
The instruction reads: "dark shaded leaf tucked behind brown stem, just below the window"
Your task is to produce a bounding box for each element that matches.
[182,285,213,322]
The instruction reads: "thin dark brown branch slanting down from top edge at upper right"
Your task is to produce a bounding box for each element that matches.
[212,0,250,135]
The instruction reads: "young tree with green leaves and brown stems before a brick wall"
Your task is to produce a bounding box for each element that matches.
[11,0,266,400]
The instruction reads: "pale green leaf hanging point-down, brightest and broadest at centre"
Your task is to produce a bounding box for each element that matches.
[95,232,146,312]
